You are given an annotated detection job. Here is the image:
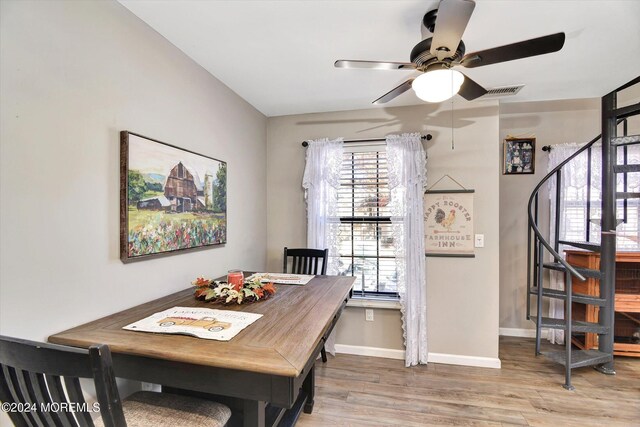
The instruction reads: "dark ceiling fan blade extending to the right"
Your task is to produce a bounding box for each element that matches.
[460,33,565,68]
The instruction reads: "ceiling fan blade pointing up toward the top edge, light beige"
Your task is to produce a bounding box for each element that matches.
[431,0,476,61]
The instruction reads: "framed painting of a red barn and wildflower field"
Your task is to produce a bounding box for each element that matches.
[120,131,227,263]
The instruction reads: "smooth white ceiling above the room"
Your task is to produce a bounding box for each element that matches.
[119,0,640,116]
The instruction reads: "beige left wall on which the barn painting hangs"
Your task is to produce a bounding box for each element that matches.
[0,0,266,340]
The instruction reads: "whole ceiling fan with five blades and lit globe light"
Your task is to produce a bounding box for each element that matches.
[334,0,565,104]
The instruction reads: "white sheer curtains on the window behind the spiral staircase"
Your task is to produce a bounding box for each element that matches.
[548,143,640,344]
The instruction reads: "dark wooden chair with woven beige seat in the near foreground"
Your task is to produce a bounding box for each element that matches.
[0,336,231,427]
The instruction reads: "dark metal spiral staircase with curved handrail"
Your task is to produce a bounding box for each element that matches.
[527,77,640,390]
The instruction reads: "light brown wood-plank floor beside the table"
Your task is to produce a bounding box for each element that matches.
[297,337,640,427]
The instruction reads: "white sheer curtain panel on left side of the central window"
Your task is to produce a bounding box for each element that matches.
[302,138,344,354]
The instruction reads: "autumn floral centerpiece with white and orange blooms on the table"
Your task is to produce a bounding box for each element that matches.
[191,277,276,304]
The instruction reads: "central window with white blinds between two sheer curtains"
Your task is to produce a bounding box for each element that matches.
[337,145,398,298]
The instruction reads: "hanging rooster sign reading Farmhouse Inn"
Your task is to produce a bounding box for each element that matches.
[424,190,475,258]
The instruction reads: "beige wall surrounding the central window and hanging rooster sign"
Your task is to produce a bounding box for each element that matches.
[267,101,499,358]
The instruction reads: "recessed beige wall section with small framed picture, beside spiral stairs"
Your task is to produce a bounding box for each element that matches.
[500,98,600,329]
